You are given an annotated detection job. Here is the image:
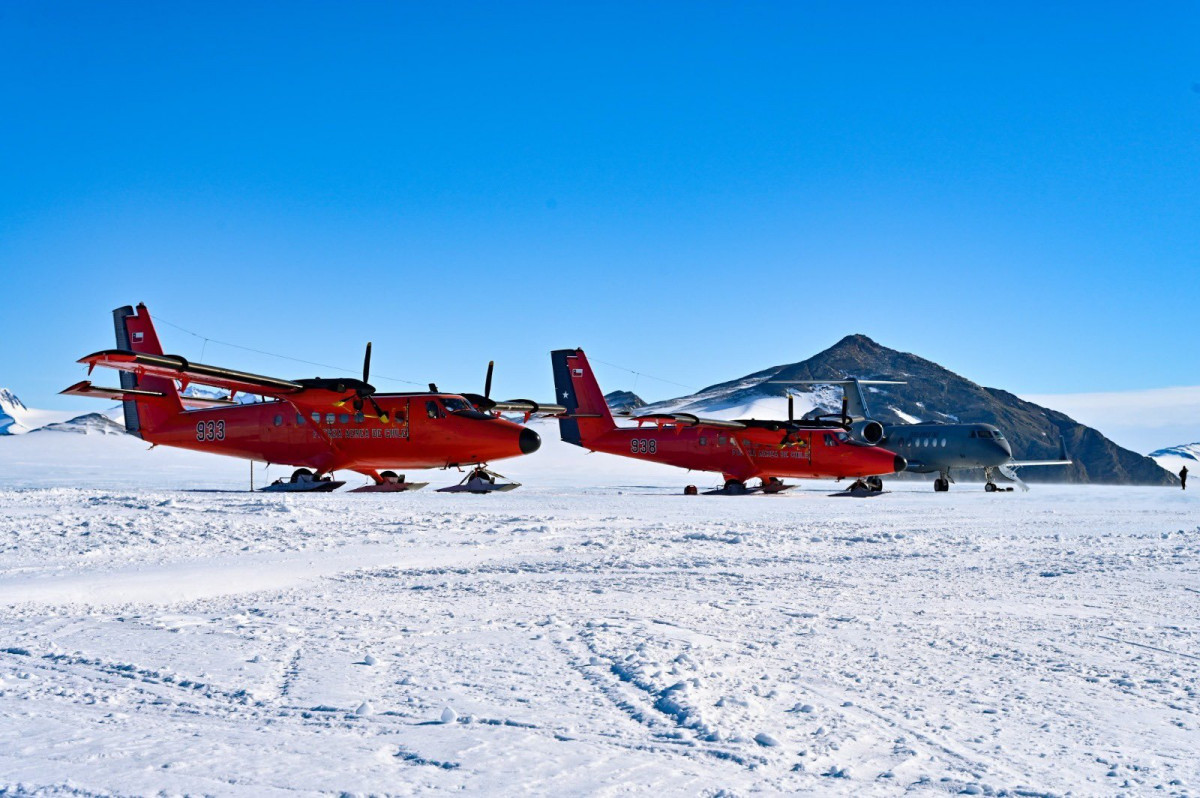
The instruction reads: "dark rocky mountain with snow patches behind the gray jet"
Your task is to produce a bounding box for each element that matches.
[644,335,1176,485]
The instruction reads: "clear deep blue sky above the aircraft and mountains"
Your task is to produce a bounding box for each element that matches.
[0,0,1200,407]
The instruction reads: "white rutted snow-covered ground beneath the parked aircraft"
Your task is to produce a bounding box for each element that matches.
[0,427,1200,796]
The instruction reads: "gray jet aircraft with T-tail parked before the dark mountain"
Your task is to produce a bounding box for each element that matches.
[776,378,1070,492]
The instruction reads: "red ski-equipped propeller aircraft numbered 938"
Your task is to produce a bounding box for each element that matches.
[550,349,906,494]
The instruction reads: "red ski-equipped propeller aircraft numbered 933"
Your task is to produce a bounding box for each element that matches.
[62,305,563,493]
